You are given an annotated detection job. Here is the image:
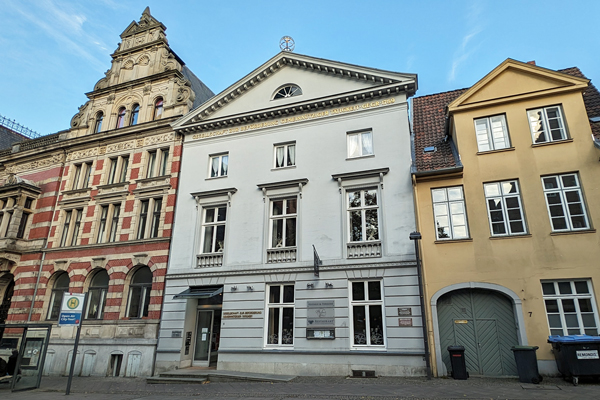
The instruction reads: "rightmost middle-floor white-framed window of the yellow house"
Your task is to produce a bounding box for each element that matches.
[542,173,590,232]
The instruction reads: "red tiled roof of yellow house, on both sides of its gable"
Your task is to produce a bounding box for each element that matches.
[412,67,600,173]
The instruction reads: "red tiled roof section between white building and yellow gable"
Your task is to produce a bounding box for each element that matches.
[412,89,467,172]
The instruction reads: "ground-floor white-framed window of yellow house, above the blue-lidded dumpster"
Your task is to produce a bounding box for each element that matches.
[542,279,598,336]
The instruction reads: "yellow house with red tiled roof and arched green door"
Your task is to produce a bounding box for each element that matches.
[412,59,600,376]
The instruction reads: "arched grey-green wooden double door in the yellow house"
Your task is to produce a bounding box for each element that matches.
[438,289,519,376]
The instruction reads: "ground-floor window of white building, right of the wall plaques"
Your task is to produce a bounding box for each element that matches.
[350,281,385,346]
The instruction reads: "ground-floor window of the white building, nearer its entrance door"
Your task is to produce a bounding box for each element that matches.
[267,284,294,346]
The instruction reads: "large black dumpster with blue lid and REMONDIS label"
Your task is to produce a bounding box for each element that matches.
[548,335,600,385]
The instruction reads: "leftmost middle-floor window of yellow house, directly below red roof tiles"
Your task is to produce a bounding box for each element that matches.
[431,186,469,240]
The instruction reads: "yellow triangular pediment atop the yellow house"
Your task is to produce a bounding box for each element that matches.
[448,58,588,111]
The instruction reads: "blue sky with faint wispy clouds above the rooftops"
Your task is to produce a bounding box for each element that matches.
[0,0,600,134]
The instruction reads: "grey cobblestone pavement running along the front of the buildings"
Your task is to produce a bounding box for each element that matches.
[0,377,600,400]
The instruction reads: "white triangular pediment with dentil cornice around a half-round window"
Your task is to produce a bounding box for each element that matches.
[173,52,416,129]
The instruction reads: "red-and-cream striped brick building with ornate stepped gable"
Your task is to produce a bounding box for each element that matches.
[0,9,213,376]
